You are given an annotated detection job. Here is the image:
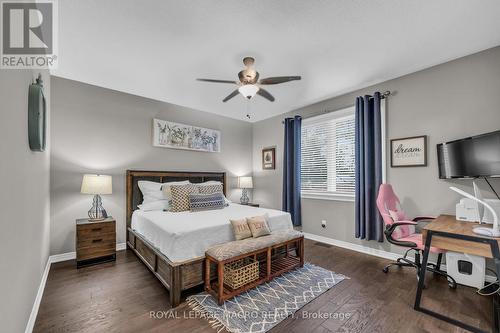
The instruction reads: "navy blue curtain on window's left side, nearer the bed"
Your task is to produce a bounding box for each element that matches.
[283,116,302,226]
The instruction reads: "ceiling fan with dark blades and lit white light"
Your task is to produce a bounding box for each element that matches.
[197,57,301,102]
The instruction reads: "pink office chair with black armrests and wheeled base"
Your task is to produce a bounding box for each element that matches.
[377,184,457,288]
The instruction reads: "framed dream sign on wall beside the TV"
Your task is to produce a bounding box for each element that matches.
[391,135,427,168]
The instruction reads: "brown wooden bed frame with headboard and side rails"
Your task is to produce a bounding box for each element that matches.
[126,170,227,308]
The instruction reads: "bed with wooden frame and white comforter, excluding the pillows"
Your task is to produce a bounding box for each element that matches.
[126,170,293,307]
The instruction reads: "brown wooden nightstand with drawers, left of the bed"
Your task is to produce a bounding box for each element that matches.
[76,217,116,268]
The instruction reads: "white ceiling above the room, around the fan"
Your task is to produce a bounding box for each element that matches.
[53,0,500,121]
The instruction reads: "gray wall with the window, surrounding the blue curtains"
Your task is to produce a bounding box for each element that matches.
[253,47,500,252]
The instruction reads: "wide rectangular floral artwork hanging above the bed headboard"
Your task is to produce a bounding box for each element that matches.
[153,119,221,153]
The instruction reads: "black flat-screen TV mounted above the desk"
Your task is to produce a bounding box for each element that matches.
[437,131,500,179]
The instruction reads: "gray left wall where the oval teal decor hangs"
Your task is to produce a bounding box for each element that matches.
[0,70,50,332]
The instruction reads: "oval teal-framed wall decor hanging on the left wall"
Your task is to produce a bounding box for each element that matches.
[28,74,47,152]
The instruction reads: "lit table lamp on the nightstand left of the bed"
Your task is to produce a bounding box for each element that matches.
[80,175,113,221]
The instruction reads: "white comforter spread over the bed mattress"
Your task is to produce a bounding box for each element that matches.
[132,203,293,262]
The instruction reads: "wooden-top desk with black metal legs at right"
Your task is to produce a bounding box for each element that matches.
[414,215,500,332]
